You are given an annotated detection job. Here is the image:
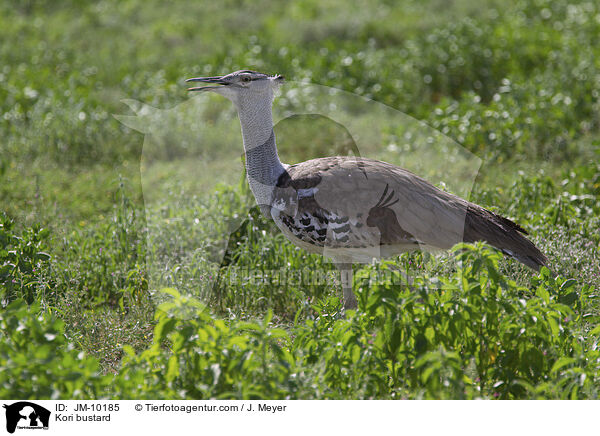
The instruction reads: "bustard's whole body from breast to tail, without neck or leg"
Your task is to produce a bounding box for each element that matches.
[271,156,546,269]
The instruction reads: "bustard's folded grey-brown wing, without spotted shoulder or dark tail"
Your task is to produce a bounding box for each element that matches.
[288,157,466,248]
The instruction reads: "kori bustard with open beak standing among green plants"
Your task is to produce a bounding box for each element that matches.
[186,70,548,310]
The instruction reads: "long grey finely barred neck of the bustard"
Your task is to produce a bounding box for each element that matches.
[238,101,285,214]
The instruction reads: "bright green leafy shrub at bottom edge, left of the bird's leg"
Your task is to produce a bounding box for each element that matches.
[116,289,296,399]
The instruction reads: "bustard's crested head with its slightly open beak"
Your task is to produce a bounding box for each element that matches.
[186,70,283,106]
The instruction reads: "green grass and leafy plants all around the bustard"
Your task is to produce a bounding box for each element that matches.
[0,0,600,399]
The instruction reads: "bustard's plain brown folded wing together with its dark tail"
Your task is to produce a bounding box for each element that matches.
[280,156,547,269]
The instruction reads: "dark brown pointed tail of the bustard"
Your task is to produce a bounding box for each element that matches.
[463,204,548,271]
